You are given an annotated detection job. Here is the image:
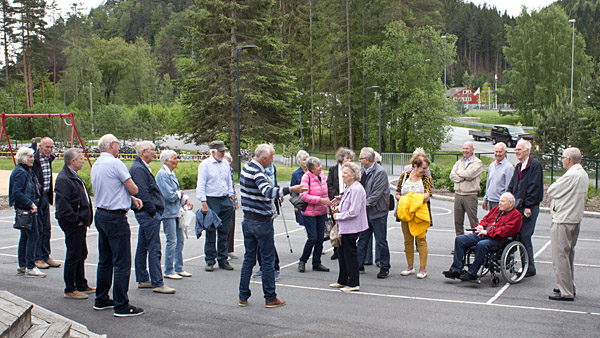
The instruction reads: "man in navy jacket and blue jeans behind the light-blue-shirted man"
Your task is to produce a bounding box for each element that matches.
[129,141,175,294]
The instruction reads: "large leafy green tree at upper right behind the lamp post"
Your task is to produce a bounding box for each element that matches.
[504,6,591,123]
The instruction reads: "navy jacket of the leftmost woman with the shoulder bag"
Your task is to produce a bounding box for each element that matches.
[8,164,40,210]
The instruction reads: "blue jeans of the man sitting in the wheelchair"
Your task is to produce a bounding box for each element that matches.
[450,234,500,276]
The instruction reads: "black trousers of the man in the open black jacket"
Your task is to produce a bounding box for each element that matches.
[58,221,88,293]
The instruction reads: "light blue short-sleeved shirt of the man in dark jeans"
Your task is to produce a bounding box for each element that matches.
[91,152,131,210]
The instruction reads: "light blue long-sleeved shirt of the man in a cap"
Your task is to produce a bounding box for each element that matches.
[196,156,234,202]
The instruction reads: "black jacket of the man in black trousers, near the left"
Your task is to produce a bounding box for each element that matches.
[54,165,94,226]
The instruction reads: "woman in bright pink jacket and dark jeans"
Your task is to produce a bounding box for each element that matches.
[298,156,331,272]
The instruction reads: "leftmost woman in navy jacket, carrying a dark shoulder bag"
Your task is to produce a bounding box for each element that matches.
[8,147,46,277]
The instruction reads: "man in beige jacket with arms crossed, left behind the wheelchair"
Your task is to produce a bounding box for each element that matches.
[450,142,483,236]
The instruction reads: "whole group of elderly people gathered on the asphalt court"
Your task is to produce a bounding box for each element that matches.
[9,134,588,317]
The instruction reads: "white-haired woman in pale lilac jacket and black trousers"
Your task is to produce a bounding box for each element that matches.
[329,162,369,292]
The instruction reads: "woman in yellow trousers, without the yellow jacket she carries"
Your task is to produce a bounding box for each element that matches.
[396,154,433,279]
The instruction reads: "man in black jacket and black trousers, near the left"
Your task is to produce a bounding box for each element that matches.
[54,148,96,299]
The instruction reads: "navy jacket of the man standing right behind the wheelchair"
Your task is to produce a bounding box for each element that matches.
[507,156,544,210]
